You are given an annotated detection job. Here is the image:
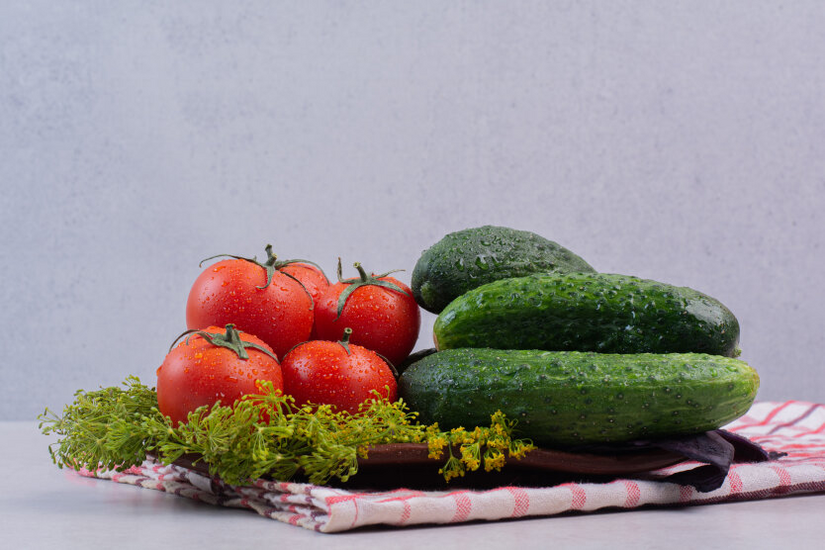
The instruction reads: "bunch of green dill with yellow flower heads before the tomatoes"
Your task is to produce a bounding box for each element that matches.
[39,376,534,485]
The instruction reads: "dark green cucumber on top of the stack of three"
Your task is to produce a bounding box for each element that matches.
[410,225,595,313]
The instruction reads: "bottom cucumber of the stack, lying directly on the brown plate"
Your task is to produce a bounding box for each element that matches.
[398,349,759,448]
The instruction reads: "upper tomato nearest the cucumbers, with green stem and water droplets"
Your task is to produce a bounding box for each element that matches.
[315,260,421,365]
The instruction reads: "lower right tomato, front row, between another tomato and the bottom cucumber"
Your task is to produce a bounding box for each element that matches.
[281,331,398,413]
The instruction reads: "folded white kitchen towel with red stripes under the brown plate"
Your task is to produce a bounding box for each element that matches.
[81,401,825,533]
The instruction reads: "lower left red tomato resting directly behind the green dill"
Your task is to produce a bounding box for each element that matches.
[157,324,283,425]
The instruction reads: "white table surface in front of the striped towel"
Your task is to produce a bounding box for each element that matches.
[6,422,825,550]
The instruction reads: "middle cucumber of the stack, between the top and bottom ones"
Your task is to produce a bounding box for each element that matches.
[433,273,739,357]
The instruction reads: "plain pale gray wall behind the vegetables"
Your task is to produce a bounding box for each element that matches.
[0,0,825,419]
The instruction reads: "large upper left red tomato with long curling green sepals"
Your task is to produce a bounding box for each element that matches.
[186,246,314,357]
